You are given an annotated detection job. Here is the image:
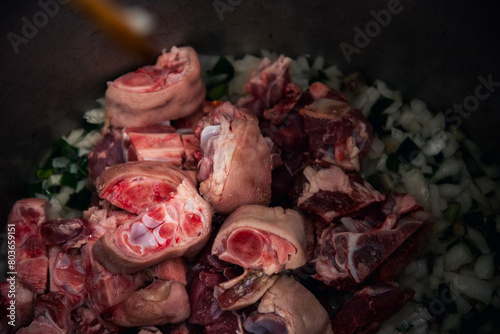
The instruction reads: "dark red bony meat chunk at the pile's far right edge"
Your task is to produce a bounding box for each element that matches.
[313,195,429,290]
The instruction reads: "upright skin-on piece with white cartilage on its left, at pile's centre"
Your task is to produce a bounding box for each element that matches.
[194,102,271,214]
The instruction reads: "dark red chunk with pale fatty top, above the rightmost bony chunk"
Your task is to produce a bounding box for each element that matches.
[297,165,385,223]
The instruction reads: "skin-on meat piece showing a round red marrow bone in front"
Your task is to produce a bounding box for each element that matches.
[212,205,306,275]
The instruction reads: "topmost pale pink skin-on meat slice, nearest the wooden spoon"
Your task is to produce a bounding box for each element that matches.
[106,46,205,128]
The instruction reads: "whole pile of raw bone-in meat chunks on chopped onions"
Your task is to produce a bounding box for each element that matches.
[0,47,430,334]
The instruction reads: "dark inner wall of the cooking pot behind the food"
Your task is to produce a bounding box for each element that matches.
[0,0,500,223]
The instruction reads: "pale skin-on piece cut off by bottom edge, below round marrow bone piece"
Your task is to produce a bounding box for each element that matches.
[244,276,333,334]
